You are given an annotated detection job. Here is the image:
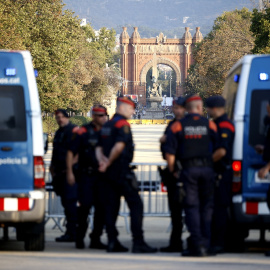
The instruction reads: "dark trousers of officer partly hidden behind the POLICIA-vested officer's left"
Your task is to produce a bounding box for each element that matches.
[166,179,183,247]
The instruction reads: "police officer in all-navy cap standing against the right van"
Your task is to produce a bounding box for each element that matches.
[206,96,235,253]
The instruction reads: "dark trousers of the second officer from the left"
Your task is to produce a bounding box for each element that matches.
[77,174,105,240]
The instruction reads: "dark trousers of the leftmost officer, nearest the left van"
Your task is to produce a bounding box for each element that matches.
[53,173,77,238]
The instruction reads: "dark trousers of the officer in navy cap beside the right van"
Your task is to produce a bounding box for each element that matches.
[211,170,233,247]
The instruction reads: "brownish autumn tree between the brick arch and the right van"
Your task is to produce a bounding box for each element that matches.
[185,8,254,98]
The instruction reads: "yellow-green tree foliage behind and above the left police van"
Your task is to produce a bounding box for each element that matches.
[0,0,118,112]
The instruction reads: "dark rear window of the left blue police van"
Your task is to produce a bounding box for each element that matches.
[0,85,27,142]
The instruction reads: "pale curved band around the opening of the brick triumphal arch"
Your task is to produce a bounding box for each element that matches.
[140,57,181,84]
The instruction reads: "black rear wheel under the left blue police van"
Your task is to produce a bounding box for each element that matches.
[24,222,45,251]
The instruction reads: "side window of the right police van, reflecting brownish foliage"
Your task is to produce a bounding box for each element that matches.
[223,65,242,120]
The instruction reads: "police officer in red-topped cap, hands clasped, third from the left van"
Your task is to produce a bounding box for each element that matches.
[96,97,157,253]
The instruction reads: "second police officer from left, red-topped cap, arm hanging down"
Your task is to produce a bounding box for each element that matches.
[67,105,107,249]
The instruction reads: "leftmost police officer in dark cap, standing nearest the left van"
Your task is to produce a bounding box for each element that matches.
[50,109,77,242]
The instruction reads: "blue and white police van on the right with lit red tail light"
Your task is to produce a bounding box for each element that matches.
[223,55,270,247]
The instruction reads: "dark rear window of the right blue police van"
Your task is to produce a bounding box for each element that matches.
[249,89,270,146]
